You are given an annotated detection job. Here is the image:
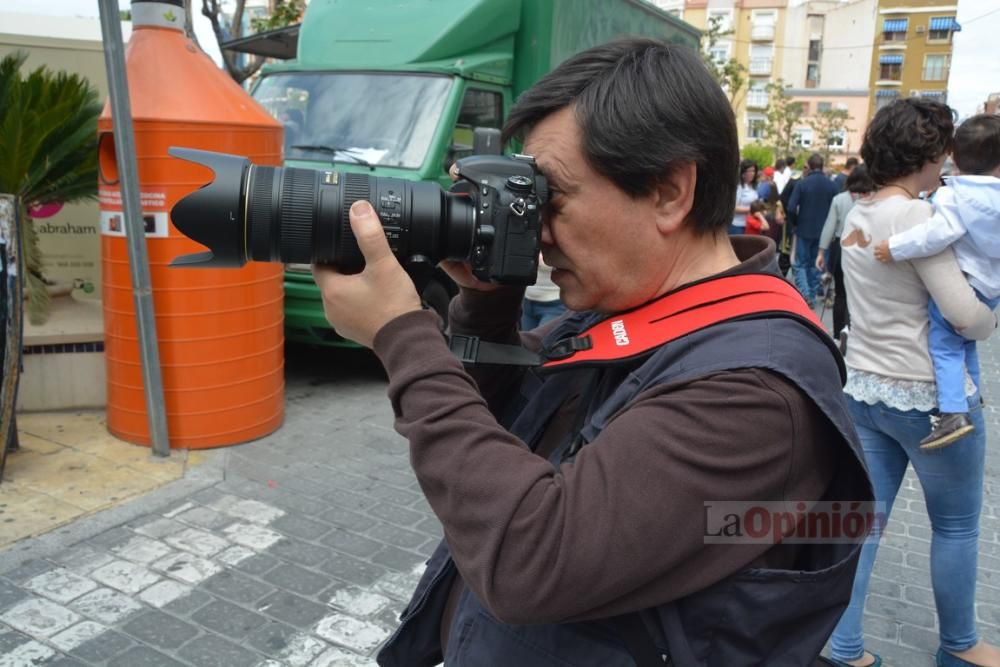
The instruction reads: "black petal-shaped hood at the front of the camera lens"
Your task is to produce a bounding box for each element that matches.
[167,147,251,268]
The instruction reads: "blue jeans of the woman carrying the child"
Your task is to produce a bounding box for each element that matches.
[830,394,986,661]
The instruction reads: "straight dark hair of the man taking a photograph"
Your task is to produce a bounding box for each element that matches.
[503,38,740,233]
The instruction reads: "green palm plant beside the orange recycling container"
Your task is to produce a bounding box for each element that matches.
[0,53,101,324]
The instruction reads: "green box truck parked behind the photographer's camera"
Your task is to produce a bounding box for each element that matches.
[246,0,700,346]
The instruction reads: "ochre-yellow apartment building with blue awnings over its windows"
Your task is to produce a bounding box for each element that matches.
[869,0,962,117]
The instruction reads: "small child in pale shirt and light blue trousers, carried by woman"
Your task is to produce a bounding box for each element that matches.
[875,114,1000,449]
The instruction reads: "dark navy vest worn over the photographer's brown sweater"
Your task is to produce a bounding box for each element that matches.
[378,314,873,667]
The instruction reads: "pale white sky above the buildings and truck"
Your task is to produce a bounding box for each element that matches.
[0,0,1000,118]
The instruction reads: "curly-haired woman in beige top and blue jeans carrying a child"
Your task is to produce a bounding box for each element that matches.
[827,98,1000,667]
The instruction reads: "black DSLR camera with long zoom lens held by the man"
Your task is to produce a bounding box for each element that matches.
[169,148,548,285]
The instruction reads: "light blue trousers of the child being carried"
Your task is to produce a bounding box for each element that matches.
[927,291,1000,412]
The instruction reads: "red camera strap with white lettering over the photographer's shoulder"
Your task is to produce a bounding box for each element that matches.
[542,274,825,369]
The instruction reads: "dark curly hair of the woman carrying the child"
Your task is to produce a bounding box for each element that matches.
[861,97,955,185]
